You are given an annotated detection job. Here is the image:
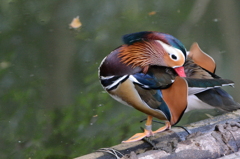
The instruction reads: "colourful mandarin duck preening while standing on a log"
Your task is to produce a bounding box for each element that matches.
[99,31,238,142]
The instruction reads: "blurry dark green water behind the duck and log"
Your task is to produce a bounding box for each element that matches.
[0,0,240,159]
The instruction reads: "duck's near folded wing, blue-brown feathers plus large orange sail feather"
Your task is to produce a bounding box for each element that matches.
[130,67,188,125]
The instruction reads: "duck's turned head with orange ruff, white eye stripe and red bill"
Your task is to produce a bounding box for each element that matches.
[118,32,187,77]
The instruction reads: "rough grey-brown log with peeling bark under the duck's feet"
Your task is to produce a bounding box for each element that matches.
[76,110,240,159]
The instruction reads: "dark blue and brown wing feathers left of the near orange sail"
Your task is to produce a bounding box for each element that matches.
[130,66,175,121]
